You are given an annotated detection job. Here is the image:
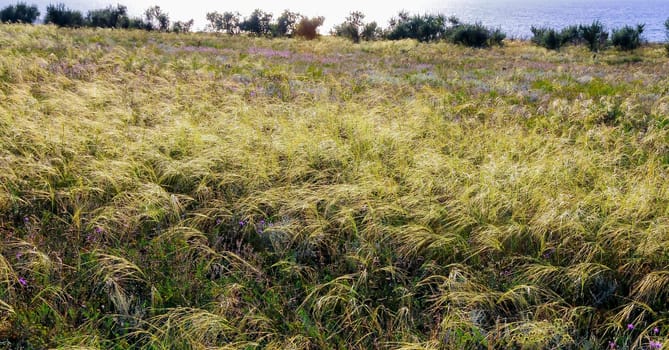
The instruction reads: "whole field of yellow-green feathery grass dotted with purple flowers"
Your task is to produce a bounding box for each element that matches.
[0,25,669,350]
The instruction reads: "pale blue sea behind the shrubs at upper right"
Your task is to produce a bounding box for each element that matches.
[435,0,669,42]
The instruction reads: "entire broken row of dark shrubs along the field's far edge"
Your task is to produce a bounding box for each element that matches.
[0,3,669,54]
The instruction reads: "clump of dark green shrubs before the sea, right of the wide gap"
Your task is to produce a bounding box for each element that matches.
[531,20,648,52]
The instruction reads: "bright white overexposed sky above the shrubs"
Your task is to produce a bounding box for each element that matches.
[6,0,439,34]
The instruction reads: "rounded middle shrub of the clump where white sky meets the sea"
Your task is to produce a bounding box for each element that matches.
[386,11,448,42]
